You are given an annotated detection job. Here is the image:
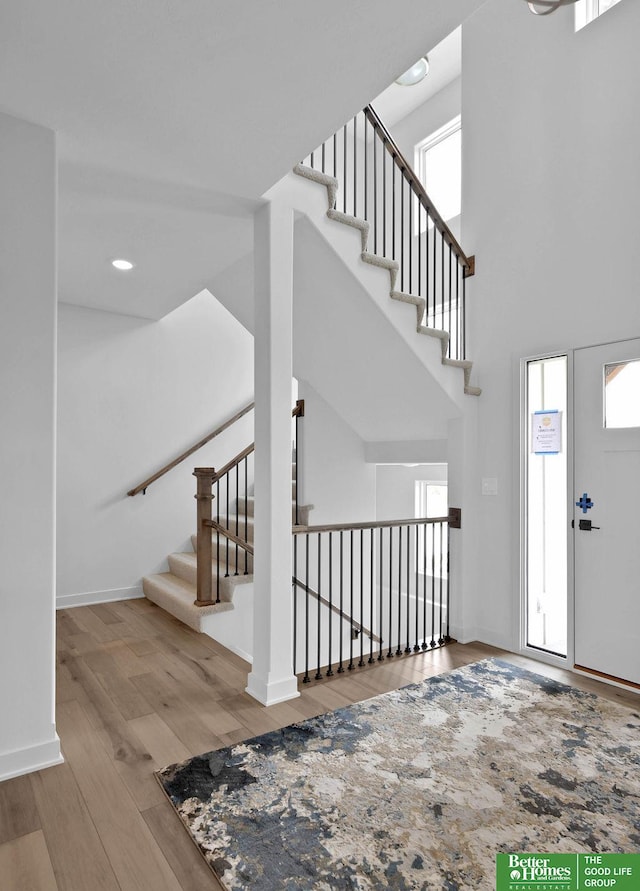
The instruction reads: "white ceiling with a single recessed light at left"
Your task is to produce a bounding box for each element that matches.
[0,0,483,318]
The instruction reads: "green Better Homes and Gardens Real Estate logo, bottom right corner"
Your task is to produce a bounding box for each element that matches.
[496,854,640,891]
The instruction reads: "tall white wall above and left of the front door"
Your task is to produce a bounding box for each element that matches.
[462,0,640,647]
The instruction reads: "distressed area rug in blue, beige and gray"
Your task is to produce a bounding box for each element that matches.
[158,659,640,891]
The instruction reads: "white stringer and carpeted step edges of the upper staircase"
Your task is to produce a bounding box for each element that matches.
[265,165,481,410]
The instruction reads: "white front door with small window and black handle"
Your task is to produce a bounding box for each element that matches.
[573,339,640,684]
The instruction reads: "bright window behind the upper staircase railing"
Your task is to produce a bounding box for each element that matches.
[415,115,462,220]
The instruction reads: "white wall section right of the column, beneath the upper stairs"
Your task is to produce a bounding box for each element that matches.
[298,380,376,525]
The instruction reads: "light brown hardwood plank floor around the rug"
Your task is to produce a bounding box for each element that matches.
[0,600,640,891]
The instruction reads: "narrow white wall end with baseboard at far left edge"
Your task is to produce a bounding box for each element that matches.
[0,115,61,780]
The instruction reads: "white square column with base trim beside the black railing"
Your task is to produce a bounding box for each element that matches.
[247,202,300,705]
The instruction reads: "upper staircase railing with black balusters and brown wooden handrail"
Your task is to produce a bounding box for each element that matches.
[304,105,475,359]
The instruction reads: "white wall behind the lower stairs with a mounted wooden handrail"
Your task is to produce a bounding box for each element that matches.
[58,291,253,605]
